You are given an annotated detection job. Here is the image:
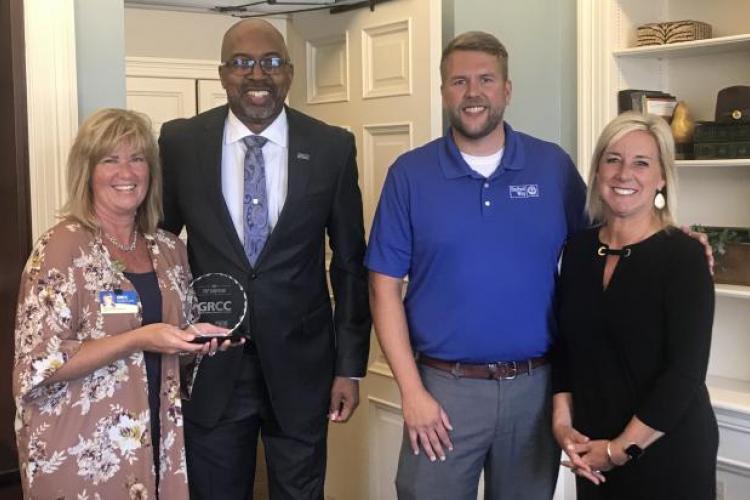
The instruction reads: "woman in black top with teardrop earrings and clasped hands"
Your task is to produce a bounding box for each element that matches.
[553,112,718,500]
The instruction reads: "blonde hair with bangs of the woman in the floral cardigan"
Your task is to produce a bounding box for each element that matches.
[60,108,162,233]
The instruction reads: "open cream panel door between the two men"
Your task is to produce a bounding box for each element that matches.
[287,0,442,500]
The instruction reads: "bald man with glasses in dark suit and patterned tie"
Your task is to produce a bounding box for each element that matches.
[159,19,370,500]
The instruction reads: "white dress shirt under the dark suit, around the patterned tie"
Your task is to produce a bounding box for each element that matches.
[221,109,289,241]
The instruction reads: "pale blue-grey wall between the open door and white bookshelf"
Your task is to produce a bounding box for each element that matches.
[450,0,577,158]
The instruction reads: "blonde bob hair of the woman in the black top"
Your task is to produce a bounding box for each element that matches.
[586,111,677,227]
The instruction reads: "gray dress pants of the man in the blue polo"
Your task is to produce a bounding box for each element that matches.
[396,365,560,500]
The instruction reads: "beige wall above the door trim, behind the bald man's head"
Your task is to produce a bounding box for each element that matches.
[125,7,286,61]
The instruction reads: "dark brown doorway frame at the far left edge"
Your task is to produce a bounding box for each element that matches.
[0,0,31,499]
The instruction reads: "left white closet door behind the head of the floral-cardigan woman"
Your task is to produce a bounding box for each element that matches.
[125,76,196,136]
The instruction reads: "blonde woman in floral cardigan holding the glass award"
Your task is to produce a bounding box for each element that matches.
[13,109,226,499]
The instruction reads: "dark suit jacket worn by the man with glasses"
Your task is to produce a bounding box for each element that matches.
[159,106,370,434]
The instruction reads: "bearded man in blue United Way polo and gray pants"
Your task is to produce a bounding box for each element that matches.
[366,32,585,500]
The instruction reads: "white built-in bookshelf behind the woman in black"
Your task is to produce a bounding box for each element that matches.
[577,0,750,500]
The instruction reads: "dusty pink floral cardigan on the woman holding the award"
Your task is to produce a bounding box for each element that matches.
[13,220,190,500]
